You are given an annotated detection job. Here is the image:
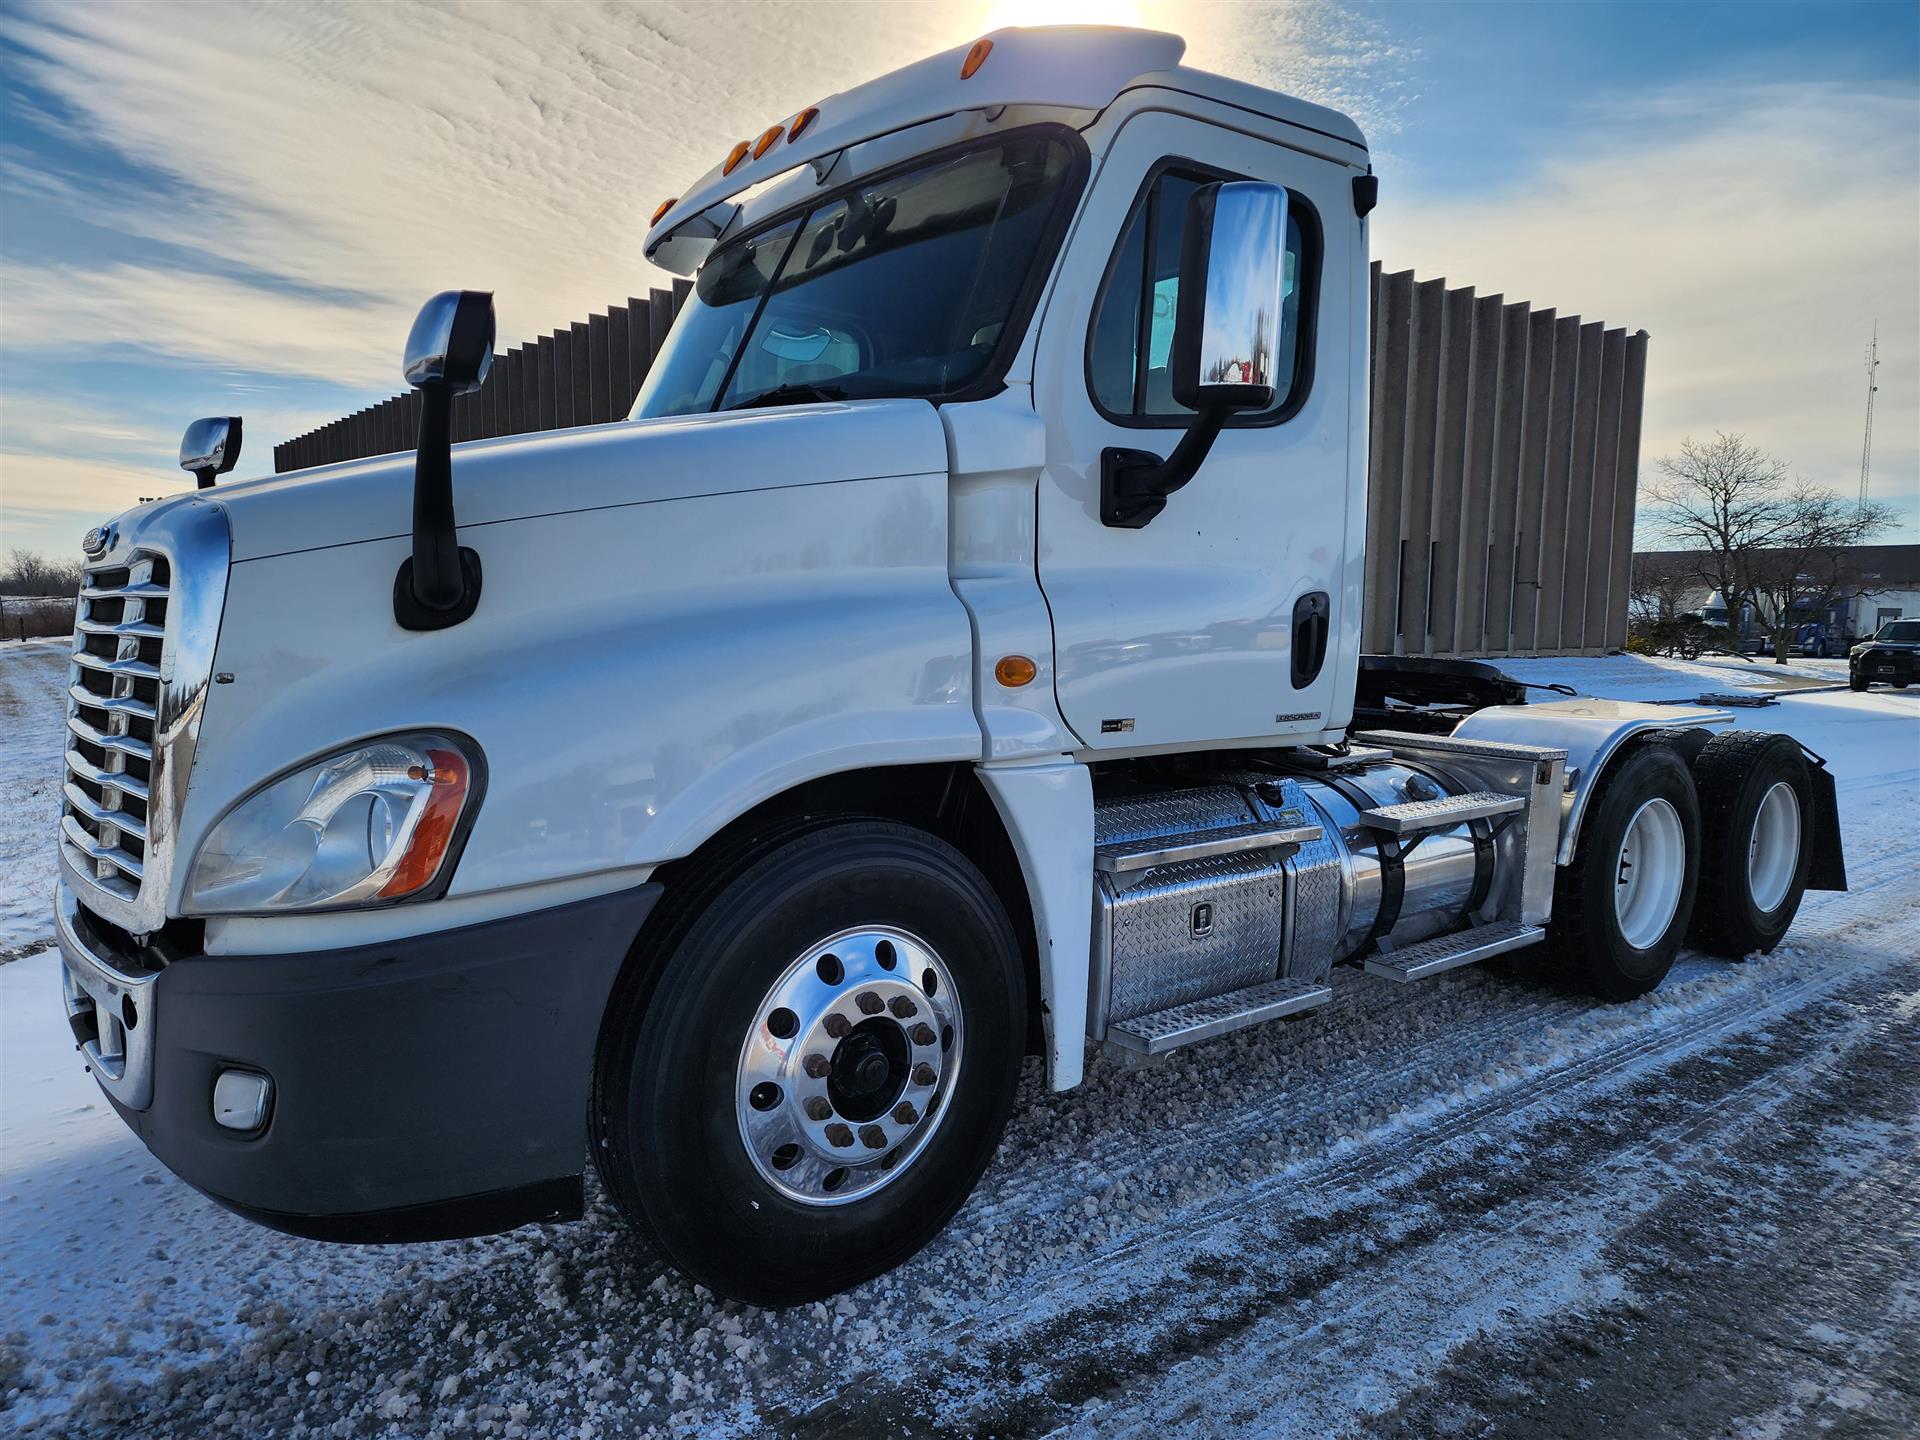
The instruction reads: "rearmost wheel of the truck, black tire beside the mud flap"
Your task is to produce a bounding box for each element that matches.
[1692,730,1812,960]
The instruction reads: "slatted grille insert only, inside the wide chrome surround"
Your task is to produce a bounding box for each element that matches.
[60,549,173,900]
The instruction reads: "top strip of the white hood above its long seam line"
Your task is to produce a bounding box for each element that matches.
[159,399,947,563]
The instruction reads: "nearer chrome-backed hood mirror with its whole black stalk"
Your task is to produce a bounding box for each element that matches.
[394,290,493,630]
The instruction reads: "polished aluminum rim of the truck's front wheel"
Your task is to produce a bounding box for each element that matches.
[733,925,962,1206]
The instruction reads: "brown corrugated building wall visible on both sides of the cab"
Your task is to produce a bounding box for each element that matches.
[273,265,1647,655]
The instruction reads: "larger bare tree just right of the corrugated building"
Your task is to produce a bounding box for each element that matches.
[1647,434,1791,626]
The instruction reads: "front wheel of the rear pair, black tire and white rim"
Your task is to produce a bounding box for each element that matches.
[1551,743,1699,1000]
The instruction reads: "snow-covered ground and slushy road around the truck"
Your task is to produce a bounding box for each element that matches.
[0,645,1920,1438]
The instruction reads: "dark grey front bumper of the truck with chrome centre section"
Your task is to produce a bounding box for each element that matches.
[58,883,660,1240]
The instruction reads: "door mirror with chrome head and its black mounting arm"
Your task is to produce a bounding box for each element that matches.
[1100,180,1292,530]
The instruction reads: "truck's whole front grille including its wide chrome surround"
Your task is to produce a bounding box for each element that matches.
[60,497,230,935]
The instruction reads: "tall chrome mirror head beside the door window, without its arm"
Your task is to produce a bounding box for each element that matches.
[1171,180,1286,411]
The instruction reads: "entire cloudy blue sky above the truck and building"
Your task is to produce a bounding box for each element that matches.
[0,0,1920,559]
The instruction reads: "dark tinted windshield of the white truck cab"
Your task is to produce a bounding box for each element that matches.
[634,134,1073,419]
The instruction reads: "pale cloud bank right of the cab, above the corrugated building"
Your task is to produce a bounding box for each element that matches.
[1375,84,1920,538]
